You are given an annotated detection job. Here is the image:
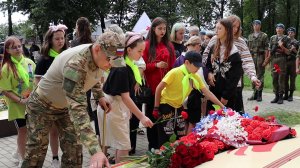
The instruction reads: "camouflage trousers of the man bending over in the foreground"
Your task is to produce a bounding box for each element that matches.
[22,91,82,168]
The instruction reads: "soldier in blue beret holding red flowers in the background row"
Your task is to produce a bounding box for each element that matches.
[268,23,290,104]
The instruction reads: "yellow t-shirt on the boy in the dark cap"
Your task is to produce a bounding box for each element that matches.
[160,67,205,108]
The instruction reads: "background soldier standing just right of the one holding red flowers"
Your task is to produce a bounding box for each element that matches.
[283,27,299,101]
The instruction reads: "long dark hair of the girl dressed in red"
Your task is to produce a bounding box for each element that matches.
[147,17,174,62]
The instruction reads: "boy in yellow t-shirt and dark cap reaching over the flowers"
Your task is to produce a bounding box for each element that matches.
[154,51,224,146]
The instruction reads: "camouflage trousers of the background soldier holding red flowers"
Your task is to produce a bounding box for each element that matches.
[271,55,286,94]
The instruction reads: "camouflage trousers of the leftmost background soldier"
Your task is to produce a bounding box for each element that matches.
[252,54,265,91]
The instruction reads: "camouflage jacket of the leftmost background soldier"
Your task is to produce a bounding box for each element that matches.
[248,32,269,54]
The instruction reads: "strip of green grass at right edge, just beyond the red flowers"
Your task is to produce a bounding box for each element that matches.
[259,111,300,127]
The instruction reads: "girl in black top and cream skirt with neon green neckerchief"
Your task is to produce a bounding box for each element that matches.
[100,32,153,163]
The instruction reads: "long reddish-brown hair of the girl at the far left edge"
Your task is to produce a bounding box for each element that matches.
[0,36,22,78]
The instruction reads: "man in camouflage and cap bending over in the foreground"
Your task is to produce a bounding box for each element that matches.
[22,31,124,168]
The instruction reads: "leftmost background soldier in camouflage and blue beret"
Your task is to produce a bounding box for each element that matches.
[248,20,268,101]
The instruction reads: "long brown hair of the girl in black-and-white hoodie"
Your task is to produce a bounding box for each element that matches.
[213,19,233,61]
